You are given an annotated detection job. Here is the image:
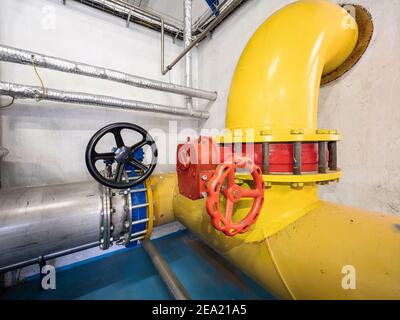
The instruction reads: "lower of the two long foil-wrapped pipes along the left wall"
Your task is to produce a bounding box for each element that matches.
[0,81,209,119]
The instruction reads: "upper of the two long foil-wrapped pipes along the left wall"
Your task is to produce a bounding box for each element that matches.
[0,45,217,100]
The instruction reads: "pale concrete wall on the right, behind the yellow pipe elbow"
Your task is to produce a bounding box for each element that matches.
[199,0,400,214]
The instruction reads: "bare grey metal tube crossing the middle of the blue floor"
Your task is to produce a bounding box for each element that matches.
[142,240,191,300]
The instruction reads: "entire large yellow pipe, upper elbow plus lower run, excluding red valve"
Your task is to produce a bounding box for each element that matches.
[155,0,400,299]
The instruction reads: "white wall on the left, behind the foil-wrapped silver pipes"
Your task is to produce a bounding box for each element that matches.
[0,0,203,187]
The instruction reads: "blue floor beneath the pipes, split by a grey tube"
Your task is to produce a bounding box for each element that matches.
[0,231,274,300]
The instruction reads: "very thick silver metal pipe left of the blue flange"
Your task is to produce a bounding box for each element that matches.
[0,182,102,267]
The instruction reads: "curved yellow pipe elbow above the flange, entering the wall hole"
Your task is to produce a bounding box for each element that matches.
[226,0,358,135]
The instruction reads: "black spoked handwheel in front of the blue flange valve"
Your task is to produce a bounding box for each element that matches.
[85,122,158,189]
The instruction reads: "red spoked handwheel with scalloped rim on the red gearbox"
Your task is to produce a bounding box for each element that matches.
[206,156,265,236]
